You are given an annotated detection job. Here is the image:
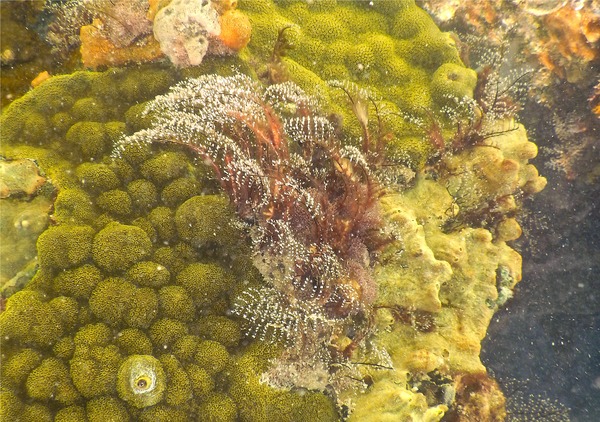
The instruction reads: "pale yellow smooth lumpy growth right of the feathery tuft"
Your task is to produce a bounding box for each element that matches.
[353,120,546,421]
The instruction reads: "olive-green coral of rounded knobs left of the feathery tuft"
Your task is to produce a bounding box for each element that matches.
[0,64,337,421]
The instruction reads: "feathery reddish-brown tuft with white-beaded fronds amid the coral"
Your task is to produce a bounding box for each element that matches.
[116,74,392,396]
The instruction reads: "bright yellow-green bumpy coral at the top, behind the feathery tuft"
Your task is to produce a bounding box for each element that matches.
[239,0,475,166]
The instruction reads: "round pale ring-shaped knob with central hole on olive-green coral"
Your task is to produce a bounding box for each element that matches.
[117,355,166,408]
